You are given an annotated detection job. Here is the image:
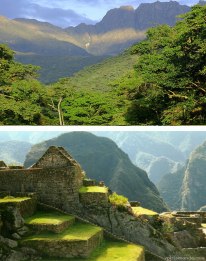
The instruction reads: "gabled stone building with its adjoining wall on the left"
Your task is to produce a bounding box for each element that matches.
[0,146,84,212]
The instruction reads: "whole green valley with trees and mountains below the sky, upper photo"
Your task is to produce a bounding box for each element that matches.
[0,1,205,125]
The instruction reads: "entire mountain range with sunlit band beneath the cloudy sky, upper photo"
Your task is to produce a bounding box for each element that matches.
[0,1,193,83]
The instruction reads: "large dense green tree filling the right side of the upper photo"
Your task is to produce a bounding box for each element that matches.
[127,5,206,125]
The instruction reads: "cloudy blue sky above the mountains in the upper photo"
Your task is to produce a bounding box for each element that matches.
[0,0,198,28]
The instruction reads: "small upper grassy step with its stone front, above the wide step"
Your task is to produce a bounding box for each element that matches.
[26,212,75,233]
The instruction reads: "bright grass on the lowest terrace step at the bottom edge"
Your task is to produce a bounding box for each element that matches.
[39,240,144,261]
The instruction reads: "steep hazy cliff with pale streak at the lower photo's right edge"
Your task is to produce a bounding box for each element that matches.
[158,138,206,211]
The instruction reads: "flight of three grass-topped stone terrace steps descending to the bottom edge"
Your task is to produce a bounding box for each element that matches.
[21,211,145,261]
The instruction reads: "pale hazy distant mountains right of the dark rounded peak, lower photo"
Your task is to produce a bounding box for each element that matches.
[95,131,185,184]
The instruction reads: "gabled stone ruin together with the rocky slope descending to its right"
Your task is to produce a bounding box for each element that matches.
[0,146,205,257]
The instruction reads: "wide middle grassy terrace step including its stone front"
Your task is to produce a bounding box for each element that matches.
[21,222,103,258]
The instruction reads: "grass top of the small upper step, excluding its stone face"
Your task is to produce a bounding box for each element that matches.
[26,212,74,225]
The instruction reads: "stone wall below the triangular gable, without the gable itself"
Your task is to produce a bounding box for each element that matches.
[0,166,82,212]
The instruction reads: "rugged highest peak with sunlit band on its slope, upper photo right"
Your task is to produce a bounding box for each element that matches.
[65,1,190,54]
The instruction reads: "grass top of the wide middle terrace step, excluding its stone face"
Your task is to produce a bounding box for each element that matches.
[23,223,102,241]
